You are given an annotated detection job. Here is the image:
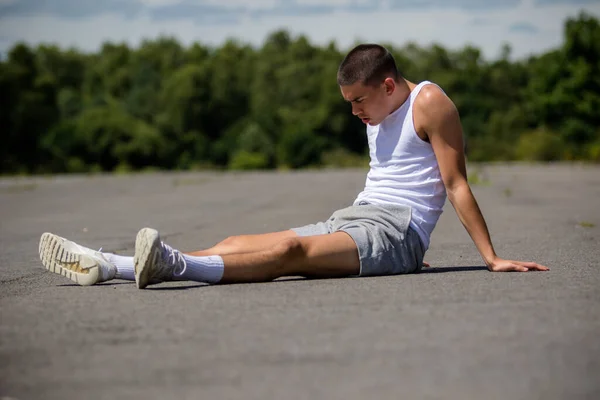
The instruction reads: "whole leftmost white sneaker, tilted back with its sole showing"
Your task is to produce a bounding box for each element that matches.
[39,232,117,286]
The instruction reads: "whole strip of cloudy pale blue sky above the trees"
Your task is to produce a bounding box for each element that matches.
[0,0,600,59]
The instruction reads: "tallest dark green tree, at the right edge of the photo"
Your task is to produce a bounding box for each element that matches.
[526,13,600,159]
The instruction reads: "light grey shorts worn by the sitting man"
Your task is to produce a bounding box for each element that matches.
[292,202,425,276]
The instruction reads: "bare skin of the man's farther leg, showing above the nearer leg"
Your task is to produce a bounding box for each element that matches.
[185,230,298,257]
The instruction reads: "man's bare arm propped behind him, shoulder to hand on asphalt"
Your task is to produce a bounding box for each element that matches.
[415,86,548,271]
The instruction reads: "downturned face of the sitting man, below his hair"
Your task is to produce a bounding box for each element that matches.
[340,78,396,125]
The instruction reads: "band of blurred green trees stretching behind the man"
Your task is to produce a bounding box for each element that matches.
[0,13,600,173]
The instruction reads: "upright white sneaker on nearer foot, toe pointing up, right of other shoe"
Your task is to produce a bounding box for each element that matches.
[133,228,185,289]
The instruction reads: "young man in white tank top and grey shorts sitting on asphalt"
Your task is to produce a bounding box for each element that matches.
[39,44,548,289]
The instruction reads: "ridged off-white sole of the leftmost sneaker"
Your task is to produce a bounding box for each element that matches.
[39,232,100,286]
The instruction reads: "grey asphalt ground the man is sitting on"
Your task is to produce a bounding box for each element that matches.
[0,164,600,400]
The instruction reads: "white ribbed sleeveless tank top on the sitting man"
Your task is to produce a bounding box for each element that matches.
[354,81,446,249]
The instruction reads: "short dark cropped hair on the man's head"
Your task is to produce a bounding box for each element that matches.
[337,44,399,86]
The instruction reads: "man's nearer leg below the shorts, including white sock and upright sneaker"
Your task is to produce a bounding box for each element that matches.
[135,228,360,289]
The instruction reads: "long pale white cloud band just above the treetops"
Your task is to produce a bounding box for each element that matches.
[0,0,600,58]
